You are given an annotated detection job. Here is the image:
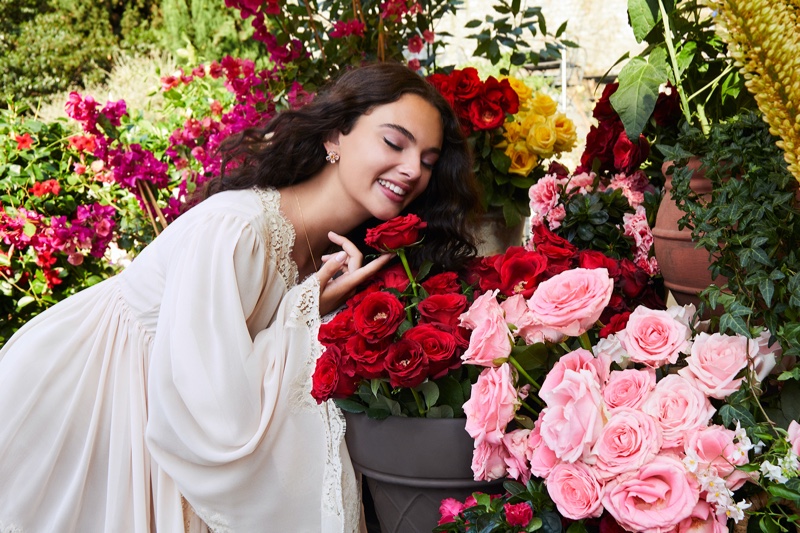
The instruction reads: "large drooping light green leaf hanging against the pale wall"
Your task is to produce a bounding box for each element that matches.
[610,47,669,139]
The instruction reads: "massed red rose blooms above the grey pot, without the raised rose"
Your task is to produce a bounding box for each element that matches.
[311,266,469,403]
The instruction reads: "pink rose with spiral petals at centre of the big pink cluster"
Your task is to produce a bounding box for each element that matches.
[592,407,662,479]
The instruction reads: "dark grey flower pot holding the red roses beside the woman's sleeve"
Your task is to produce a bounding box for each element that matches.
[345,413,503,533]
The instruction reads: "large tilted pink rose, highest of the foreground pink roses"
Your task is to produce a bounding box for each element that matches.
[528,268,614,340]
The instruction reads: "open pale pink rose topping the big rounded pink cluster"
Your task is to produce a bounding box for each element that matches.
[617,306,691,368]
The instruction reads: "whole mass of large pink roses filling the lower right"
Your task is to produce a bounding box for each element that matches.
[437,280,800,532]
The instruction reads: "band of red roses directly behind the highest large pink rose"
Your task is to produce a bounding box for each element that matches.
[467,225,664,320]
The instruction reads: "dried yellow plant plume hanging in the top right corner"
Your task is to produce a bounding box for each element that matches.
[707,0,800,182]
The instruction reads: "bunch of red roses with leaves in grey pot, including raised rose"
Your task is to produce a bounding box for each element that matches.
[311,214,470,418]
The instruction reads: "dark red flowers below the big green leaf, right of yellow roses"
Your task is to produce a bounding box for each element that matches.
[576,83,678,174]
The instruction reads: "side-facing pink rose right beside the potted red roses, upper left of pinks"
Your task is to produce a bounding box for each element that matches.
[461,290,514,366]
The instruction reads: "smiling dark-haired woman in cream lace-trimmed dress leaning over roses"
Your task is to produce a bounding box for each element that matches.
[0,64,476,533]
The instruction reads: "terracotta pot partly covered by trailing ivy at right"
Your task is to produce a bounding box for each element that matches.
[653,159,727,305]
